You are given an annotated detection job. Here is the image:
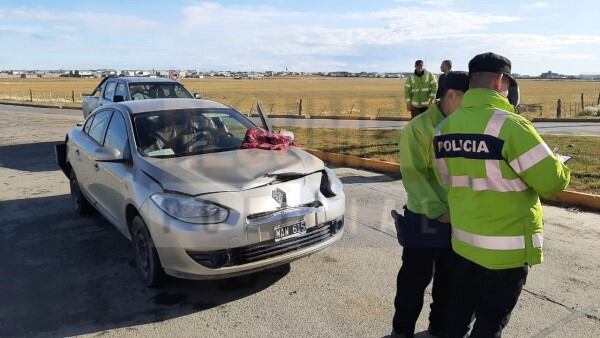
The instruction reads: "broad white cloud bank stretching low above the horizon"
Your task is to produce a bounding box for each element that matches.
[0,0,600,71]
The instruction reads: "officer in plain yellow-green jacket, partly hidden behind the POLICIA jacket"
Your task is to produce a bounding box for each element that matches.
[392,72,469,337]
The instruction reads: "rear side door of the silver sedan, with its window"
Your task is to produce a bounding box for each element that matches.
[74,110,112,197]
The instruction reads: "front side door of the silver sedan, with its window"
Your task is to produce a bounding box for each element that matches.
[92,110,133,231]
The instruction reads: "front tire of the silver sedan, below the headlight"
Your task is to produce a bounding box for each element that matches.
[131,216,166,287]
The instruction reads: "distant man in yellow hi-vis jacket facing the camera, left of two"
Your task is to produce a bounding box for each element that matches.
[404,60,437,118]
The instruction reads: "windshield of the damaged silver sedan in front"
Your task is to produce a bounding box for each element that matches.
[133,108,254,157]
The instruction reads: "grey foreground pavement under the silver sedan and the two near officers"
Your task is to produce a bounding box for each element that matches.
[0,112,600,338]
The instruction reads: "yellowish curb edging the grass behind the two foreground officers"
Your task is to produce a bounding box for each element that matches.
[305,149,600,211]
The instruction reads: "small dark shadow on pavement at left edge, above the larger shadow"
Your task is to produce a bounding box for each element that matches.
[0,142,60,172]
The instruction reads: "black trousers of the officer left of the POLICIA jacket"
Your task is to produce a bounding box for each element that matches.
[393,248,453,337]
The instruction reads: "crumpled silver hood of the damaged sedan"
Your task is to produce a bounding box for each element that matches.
[140,147,325,195]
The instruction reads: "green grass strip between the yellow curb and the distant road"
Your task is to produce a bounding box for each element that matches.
[278,127,600,194]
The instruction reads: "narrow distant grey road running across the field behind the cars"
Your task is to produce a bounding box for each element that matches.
[0,104,600,136]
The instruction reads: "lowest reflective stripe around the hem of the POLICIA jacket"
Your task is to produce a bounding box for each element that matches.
[452,227,544,250]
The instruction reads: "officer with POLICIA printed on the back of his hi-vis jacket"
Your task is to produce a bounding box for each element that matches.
[433,53,570,338]
